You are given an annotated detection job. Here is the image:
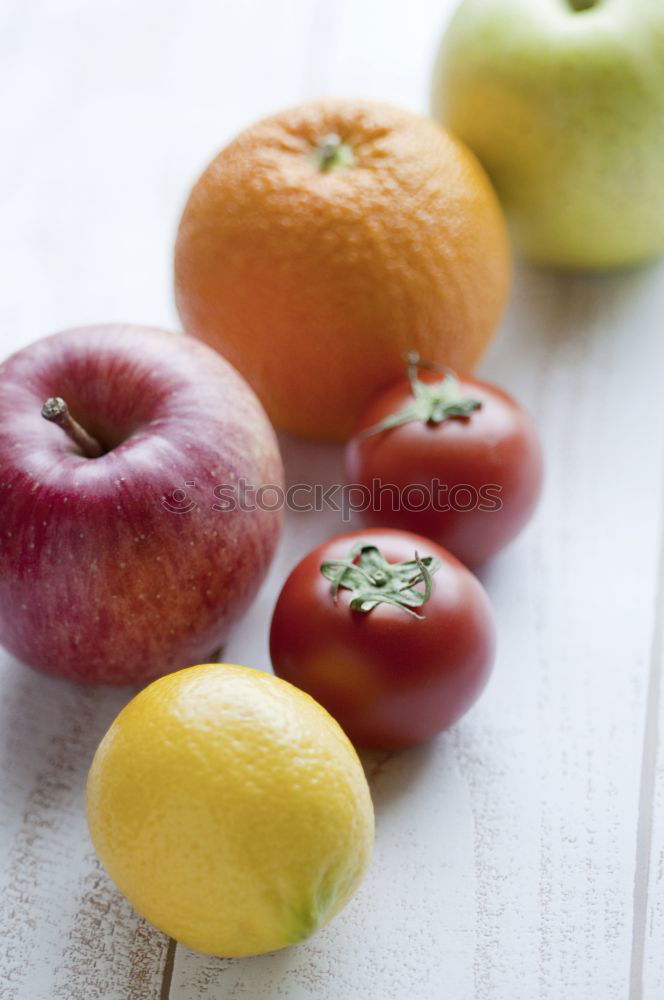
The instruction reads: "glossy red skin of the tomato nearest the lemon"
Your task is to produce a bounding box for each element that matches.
[270,529,495,750]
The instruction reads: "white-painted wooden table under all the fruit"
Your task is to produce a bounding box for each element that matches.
[0,0,664,1000]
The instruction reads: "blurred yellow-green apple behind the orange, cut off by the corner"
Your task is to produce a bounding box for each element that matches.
[433,0,664,270]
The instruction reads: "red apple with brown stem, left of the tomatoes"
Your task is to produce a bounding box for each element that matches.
[0,326,283,684]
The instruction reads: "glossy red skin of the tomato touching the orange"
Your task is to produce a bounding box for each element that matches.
[346,375,542,566]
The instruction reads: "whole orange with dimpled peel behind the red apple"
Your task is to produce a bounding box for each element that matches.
[175,100,511,440]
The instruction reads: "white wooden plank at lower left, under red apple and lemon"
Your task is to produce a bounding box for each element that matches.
[0,654,166,1000]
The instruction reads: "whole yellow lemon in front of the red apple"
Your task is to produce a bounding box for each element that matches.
[87,664,374,958]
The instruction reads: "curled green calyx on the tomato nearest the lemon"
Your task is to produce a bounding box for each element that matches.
[320,542,441,618]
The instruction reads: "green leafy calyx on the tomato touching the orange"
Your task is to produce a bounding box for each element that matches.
[358,353,482,439]
